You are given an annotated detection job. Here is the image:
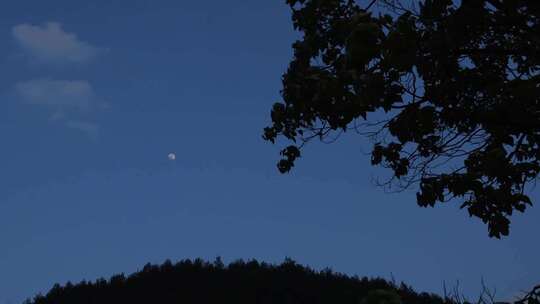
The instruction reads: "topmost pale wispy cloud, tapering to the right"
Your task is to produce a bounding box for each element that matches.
[12,22,102,63]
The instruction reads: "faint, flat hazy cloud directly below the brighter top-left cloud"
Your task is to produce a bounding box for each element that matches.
[15,79,95,111]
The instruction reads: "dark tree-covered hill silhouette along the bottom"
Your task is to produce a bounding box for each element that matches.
[25,258,445,304]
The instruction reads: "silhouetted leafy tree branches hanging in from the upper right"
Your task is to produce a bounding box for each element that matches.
[263,0,540,238]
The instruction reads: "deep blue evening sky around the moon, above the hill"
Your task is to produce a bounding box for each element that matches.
[0,0,540,304]
